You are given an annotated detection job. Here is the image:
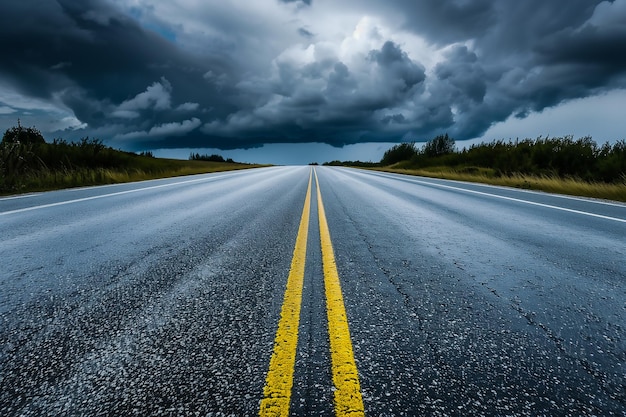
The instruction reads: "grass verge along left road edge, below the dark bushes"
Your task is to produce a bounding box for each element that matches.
[0,156,263,195]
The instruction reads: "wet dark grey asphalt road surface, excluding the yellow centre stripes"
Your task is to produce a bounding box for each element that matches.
[0,167,626,416]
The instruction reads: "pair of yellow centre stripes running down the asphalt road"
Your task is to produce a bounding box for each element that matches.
[259,170,365,417]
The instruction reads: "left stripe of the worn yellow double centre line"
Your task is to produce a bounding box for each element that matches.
[259,173,312,417]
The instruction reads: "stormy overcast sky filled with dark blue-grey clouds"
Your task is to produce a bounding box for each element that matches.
[0,0,626,163]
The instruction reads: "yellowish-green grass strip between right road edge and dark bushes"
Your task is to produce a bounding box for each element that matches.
[373,165,626,202]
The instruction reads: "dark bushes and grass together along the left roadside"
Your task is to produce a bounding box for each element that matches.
[0,122,260,195]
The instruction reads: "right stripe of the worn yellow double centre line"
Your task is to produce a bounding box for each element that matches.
[315,167,365,417]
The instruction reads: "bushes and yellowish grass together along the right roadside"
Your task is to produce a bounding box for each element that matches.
[328,135,626,202]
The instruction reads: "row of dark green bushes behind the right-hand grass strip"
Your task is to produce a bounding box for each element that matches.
[328,134,626,183]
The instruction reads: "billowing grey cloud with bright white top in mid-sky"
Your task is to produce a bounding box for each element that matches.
[195,42,425,146]
